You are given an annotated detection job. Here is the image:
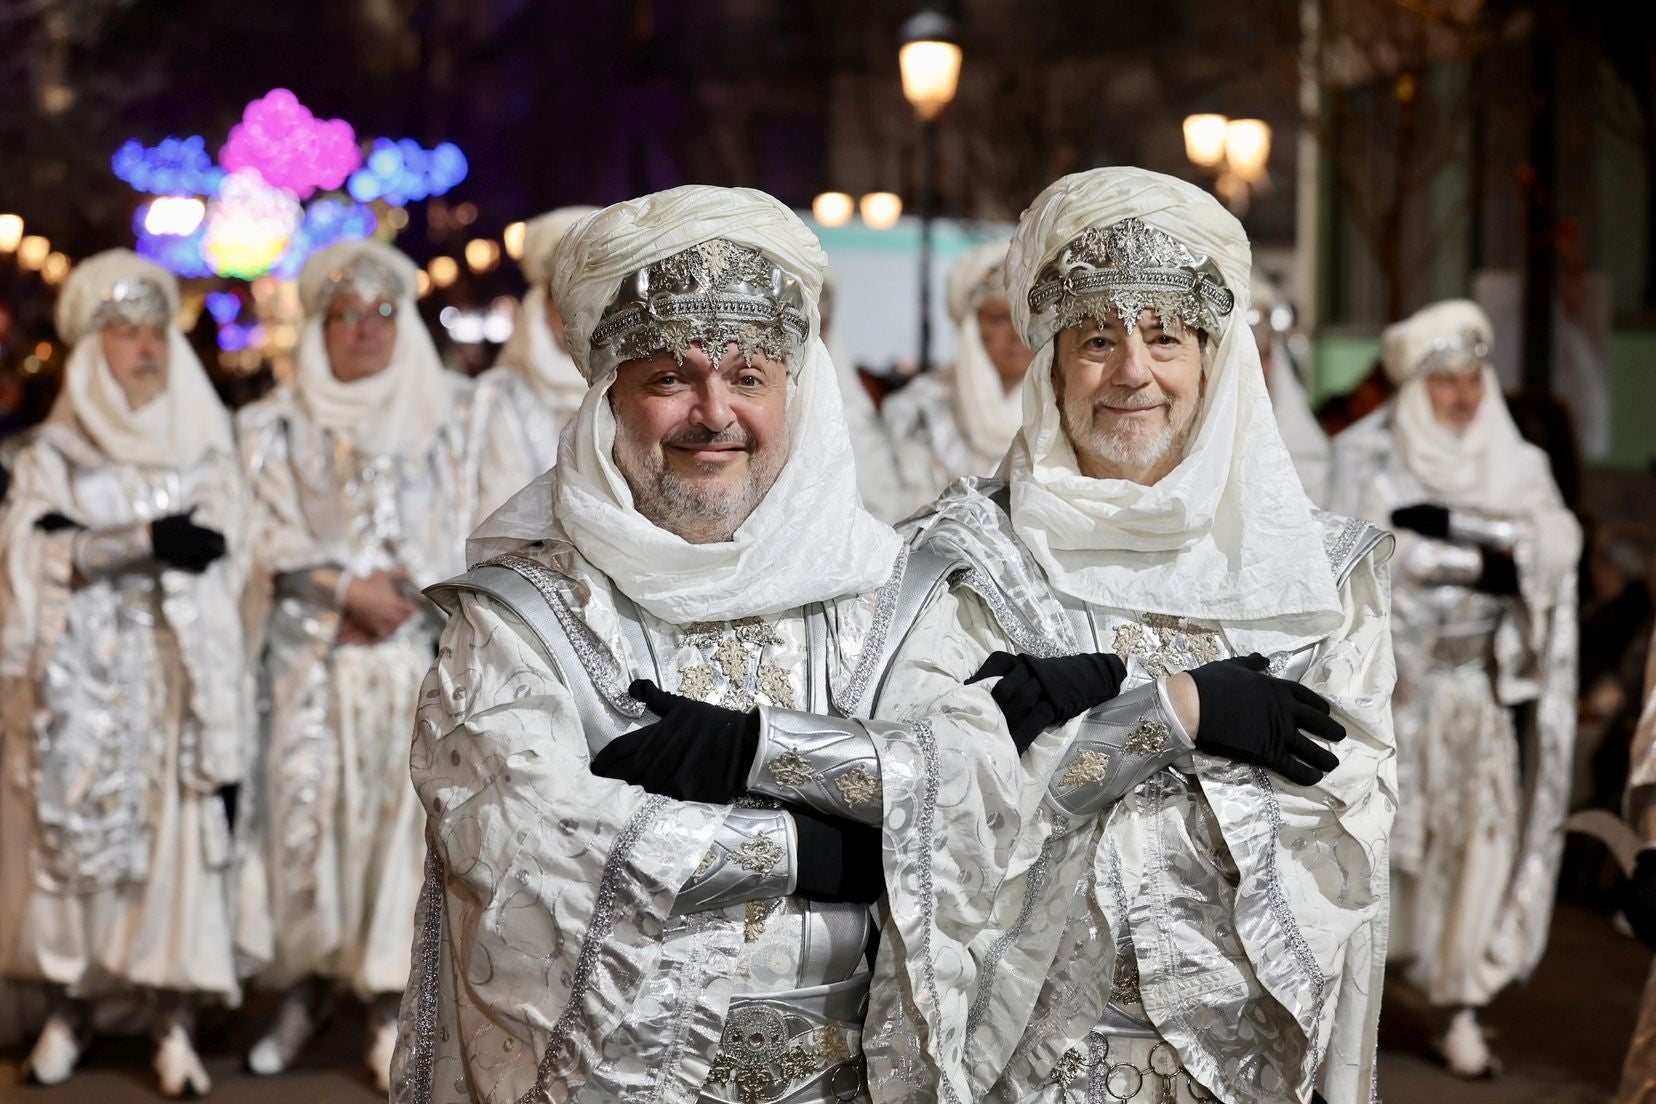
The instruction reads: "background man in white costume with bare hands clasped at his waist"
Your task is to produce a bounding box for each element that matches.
[238,242,472,1081]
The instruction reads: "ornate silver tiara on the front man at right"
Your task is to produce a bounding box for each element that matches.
[1028,218,1235,346]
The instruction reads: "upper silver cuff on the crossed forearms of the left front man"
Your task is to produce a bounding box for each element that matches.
[747,705,884,824]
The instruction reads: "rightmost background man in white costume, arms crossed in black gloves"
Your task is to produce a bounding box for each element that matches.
[1331,301,1581,1078]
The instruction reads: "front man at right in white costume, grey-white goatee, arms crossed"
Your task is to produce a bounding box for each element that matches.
[869,169,1396,1104]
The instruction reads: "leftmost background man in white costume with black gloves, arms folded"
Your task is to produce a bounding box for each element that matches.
[0,250,252,1096]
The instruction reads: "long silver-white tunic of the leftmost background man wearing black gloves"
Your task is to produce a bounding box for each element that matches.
[0,425,252,1003]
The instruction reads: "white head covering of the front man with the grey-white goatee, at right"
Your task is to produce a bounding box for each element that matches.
[1007,169,1340,652]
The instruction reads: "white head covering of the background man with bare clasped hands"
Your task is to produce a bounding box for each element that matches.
[293,238,449,455]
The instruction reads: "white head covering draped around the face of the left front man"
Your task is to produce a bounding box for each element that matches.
[467,185,899,624]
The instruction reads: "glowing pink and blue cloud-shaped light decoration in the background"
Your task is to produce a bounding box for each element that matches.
[109,88,469,284]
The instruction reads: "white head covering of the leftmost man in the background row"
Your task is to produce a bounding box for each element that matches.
[46,250,233,468]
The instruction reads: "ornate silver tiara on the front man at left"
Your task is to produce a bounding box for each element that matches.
[591,238,811,379]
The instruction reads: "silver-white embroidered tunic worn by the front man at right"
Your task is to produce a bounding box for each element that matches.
[880,482,1396,1104]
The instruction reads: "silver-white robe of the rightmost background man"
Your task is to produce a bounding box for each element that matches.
[1331,407,1580,1006]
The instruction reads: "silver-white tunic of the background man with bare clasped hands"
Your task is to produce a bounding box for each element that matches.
[237,377,472,998]
